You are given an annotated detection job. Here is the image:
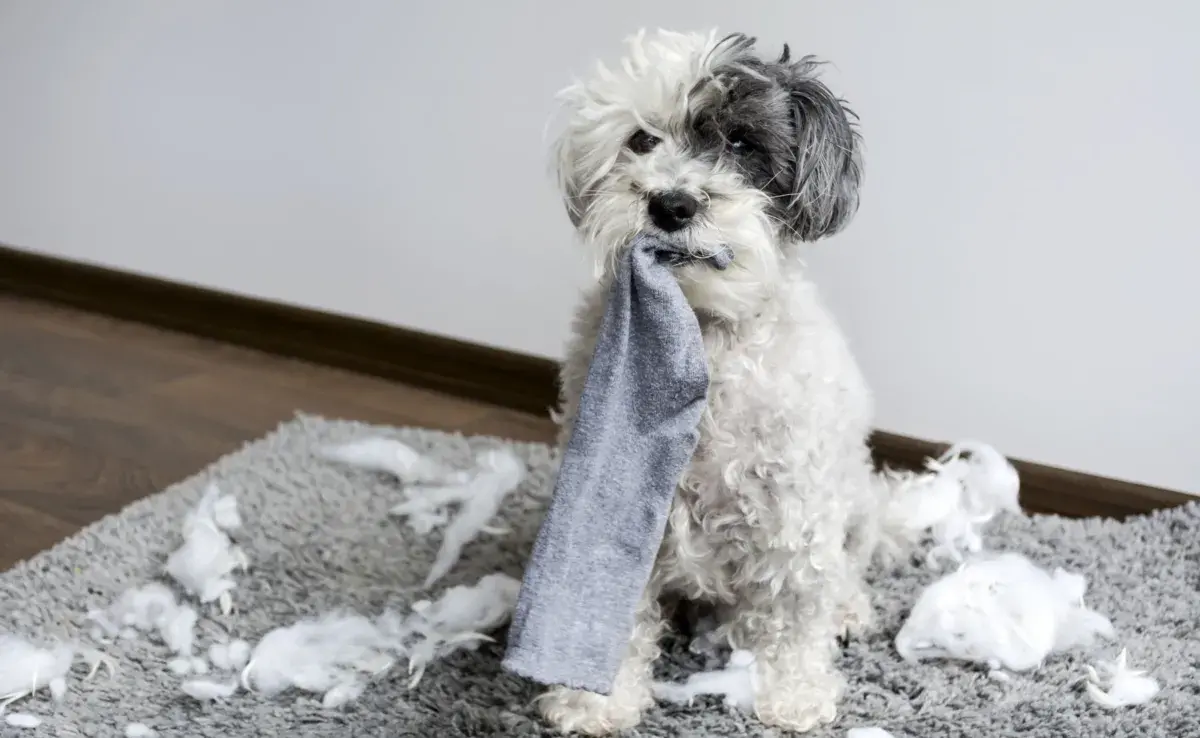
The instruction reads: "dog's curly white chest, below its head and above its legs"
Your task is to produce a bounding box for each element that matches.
[660,297,871,599]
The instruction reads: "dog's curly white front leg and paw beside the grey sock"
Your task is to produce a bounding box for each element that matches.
[538,588,664,736]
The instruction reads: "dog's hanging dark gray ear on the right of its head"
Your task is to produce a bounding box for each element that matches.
[776,58,863,241]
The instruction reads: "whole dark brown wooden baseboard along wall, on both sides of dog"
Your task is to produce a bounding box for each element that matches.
[0,246,1196,518]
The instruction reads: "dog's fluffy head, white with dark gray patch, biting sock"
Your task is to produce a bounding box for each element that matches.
[556,31,860,317]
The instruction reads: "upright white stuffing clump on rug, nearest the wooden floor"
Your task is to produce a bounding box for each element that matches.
[166,484,247,614]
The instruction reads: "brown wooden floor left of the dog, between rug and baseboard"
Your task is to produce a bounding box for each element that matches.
[0,294,553,570]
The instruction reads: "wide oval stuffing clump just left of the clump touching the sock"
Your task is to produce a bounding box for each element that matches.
[241,614,397,700]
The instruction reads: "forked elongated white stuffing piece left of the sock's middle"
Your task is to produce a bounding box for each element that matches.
[391,450,524,588]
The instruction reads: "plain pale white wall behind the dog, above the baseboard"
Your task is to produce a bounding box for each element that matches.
[0,0,1200,492]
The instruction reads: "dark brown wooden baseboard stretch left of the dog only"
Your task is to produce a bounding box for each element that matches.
[0,245,558,414]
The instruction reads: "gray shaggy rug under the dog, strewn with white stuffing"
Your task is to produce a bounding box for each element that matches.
[0,416,1200,738]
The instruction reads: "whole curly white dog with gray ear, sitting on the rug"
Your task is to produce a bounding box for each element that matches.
[538,31,902,736]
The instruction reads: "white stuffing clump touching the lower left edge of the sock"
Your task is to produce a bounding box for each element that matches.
[398,574,521,686]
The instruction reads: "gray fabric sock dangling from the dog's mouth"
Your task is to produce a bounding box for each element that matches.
[504,234,731,694]
